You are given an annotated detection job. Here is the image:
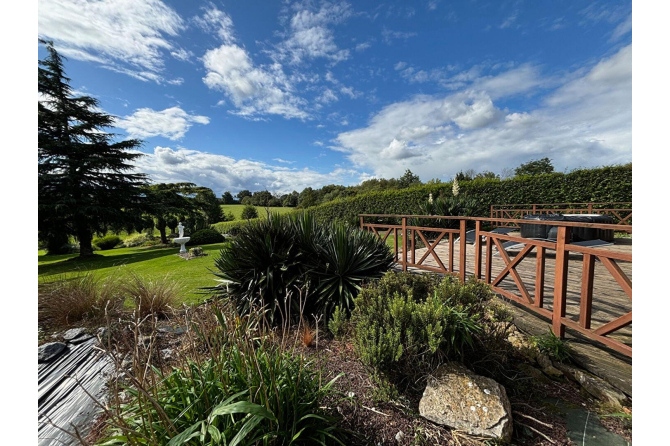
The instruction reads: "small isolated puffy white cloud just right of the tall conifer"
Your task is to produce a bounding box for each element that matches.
[115,107,209,140]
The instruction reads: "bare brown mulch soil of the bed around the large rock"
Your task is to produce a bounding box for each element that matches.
[61,306,631,446]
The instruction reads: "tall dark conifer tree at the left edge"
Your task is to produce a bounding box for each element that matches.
[38,40,146,256]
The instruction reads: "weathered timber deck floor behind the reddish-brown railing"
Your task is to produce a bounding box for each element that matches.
[396,233,633,395]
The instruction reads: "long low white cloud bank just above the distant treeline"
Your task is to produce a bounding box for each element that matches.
[135,147,359,195]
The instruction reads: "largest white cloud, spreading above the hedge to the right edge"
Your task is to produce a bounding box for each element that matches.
[331,45,632,179]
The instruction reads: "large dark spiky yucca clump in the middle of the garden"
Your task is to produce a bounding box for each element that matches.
[215,214,392,322]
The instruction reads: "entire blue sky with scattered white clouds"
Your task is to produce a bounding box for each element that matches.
[38,0,632,194]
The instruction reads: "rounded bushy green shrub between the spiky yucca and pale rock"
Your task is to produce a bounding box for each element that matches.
[352,273,492,371]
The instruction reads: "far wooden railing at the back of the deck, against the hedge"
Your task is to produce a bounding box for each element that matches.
[491,202,633,226]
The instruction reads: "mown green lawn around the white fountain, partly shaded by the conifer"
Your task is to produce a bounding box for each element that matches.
[37,243,225,303]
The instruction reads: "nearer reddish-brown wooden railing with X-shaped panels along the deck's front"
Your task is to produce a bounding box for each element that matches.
[359,214,633,357]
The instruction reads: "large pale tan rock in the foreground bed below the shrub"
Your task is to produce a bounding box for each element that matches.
[419,362,512,441]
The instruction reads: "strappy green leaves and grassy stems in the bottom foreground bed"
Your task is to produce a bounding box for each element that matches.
[102,310,343,446]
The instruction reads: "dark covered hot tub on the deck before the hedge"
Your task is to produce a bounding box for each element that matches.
[520,214,614,242]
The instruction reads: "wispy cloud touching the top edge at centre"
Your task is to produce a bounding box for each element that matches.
[275,2,352,64]
